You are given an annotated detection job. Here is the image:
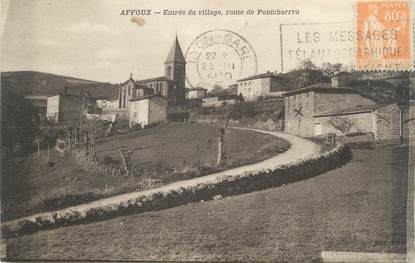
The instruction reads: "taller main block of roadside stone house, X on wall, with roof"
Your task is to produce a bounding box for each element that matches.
[284,83,375,137]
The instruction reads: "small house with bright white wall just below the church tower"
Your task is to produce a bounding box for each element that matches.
[129,94,168,127]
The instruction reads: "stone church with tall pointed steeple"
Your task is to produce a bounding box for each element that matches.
[119,36,186,109]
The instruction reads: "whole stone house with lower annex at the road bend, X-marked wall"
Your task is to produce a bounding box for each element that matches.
[284,83,402,140]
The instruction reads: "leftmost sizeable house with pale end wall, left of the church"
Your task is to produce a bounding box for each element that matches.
[46,94,96,123]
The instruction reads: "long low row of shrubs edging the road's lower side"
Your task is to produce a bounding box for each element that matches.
[2,145,352,236]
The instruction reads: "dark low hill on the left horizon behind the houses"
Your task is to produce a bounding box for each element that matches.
[1,71,118,99]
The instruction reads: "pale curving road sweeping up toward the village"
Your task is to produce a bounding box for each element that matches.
[3,128,320,226]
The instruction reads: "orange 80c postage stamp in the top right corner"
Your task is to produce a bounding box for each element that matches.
[356,1,412,70]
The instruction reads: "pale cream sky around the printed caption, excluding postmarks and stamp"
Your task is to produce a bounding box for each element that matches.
[0,0,410,83]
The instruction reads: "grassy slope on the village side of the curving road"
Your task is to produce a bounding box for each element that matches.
[1,123,289,220]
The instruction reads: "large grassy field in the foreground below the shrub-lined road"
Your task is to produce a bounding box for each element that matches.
[2,147,408,263]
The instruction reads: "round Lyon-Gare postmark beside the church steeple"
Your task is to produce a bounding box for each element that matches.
[186,30,257,90]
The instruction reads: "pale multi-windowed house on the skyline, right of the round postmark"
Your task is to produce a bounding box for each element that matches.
[237,71,286,101]
